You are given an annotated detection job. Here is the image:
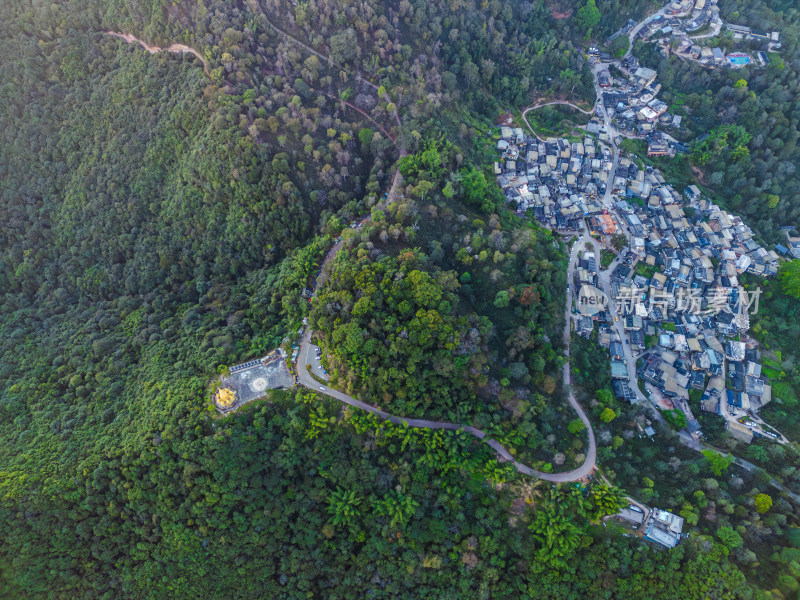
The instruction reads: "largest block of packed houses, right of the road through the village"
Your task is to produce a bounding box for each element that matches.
[608,180,778,441]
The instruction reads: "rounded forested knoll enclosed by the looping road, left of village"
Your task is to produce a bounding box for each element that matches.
[312,142,583,468]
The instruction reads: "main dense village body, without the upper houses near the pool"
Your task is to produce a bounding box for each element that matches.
[495,111,783,450]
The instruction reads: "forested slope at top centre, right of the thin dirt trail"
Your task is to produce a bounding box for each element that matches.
[262,0,594,110]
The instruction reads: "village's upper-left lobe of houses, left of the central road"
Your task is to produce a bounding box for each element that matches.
[494,127,613,231]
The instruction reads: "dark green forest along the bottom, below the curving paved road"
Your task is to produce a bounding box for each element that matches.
[0,386,747,598]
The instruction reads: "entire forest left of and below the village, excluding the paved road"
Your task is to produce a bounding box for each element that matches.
[0,0,800,599]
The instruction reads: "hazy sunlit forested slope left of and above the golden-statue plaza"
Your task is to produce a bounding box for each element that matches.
[0,0,391,496]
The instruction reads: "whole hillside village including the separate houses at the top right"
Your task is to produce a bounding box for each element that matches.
[494,0,800,462]
